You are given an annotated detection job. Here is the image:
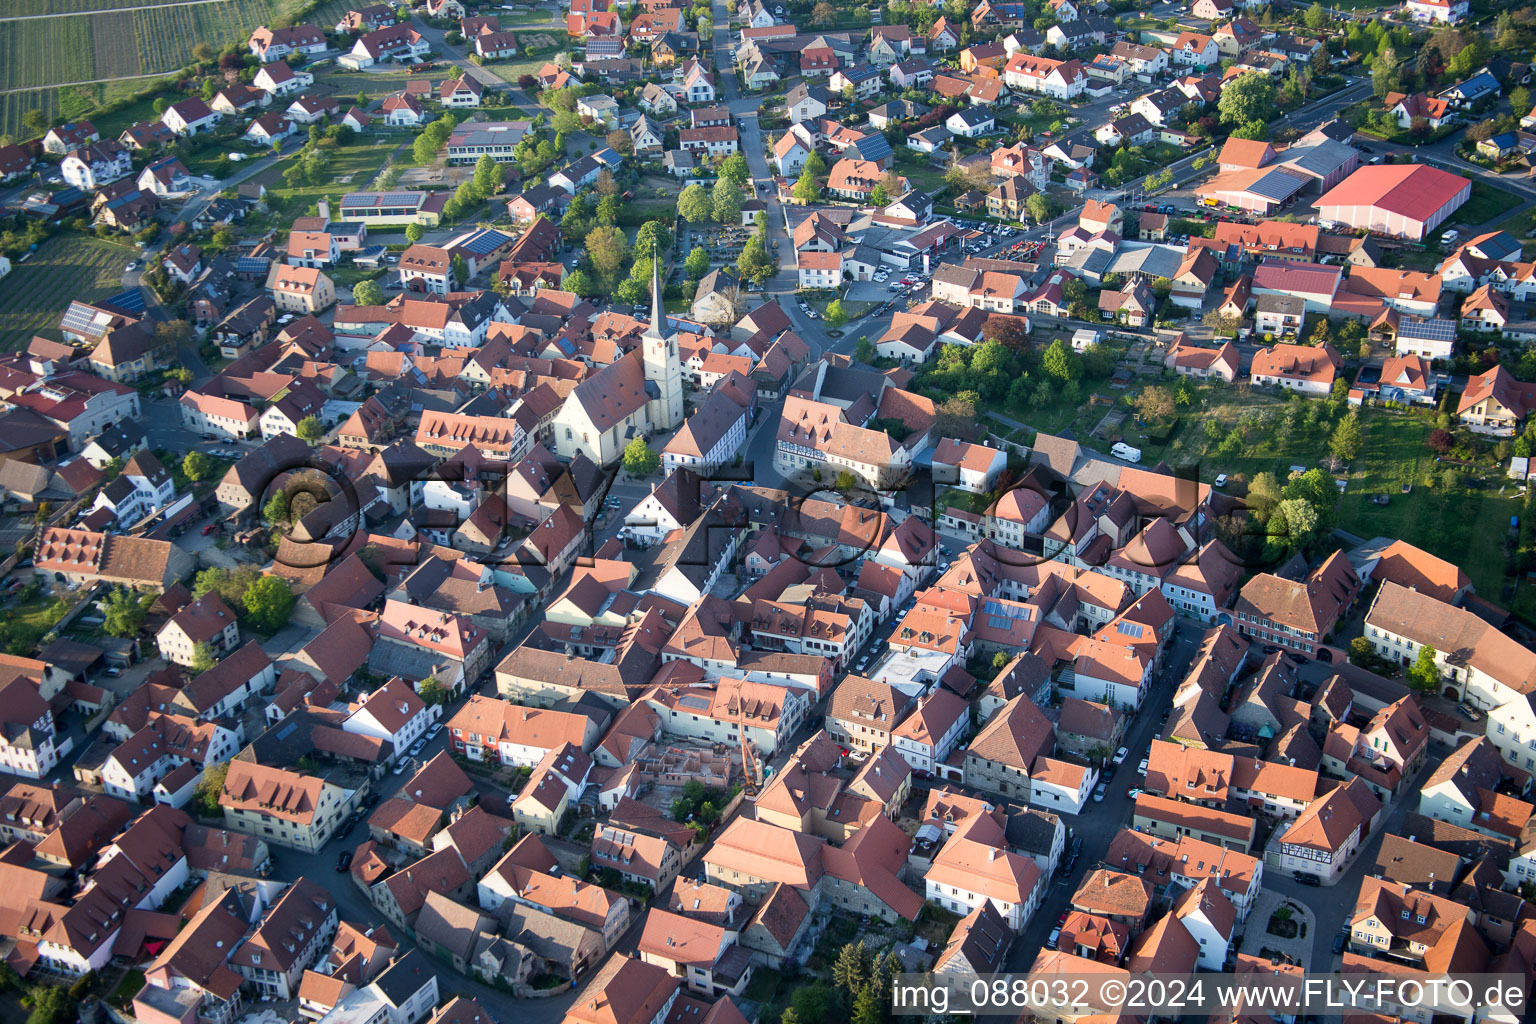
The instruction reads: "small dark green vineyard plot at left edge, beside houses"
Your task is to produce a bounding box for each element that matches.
[0,235,138,352]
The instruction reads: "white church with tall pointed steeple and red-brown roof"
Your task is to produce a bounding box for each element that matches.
[553,251,684,465]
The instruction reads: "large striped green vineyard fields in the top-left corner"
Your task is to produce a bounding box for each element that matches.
[0,0,303,135]
